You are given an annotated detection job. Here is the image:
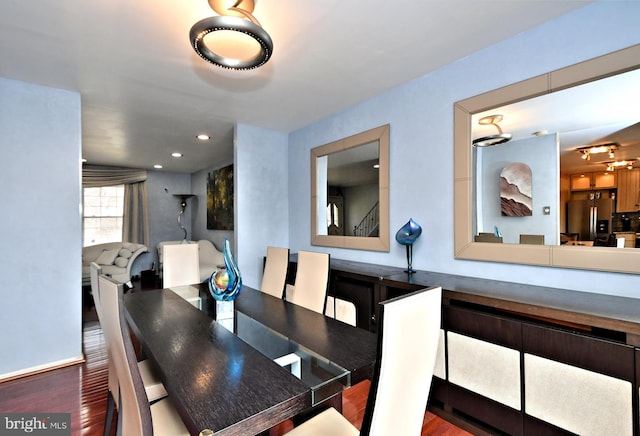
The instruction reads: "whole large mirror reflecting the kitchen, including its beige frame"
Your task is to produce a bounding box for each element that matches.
[454,46,640,273]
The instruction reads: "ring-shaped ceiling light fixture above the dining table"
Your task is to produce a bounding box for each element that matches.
[189,0,273,70]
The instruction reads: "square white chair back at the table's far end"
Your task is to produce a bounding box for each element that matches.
[162,244,200,288]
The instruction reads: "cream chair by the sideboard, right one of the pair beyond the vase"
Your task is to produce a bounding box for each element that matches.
[285,251,329,313]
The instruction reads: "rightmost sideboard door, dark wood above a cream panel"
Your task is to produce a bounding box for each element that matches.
[522,324,635,435]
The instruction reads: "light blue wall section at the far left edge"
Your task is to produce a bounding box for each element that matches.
[0,79,82,378]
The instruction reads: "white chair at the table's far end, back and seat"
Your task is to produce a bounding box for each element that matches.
[162,244,202,309]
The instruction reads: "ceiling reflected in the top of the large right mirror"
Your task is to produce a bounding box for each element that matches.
[472,70,640,173]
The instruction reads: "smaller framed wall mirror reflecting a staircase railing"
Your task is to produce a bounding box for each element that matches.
[311,125,389,251]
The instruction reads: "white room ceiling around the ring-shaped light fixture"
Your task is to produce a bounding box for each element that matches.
[0,0,590,173]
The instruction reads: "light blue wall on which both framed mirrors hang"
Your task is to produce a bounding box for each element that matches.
[284,1,640,297]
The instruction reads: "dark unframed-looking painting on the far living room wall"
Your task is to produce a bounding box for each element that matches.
[207,165,233,230]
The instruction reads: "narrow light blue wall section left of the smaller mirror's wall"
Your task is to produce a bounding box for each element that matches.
[234,124,288,288]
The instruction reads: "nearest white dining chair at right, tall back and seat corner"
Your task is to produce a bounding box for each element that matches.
[287,288,442,436]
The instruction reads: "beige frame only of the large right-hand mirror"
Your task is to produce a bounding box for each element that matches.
[454,45,640,274]
